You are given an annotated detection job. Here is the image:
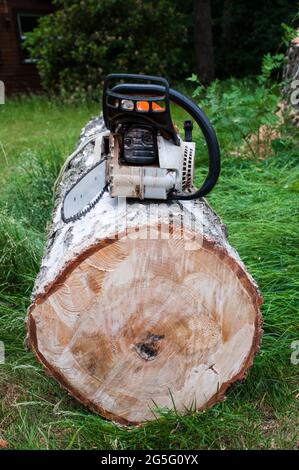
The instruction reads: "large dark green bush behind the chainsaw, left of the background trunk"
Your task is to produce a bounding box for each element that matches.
[28,0,190,99]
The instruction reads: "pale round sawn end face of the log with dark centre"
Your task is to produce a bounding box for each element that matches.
[28,222,261,423]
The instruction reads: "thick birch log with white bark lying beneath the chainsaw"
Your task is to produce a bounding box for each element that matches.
[27,118,262,424]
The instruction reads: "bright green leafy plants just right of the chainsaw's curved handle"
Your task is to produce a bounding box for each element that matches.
[193,76,279,157]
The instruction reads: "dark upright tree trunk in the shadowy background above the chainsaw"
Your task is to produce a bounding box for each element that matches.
[194,0,215,86]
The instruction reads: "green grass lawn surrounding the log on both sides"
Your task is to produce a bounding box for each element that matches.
[0,89,299,449]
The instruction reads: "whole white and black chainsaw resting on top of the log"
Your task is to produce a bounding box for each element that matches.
[62,74,220,223]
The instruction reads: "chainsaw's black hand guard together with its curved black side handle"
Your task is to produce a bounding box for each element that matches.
[103,74,221,200]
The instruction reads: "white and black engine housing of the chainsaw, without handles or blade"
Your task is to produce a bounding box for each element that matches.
[106,127,195,199]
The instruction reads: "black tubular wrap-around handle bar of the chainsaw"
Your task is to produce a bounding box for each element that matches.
[112,79,221,200]
